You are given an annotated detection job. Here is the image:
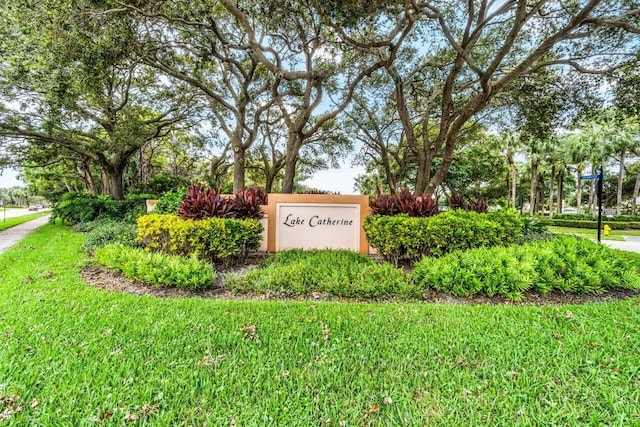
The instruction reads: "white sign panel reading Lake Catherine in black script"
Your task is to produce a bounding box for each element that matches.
[276,203,361,252]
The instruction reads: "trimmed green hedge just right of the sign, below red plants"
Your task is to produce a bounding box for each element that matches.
[364,209,522,266]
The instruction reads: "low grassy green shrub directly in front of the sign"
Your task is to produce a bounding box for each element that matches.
[227,249,418,298]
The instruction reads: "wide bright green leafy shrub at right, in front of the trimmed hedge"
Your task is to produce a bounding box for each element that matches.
[410,236,640,300]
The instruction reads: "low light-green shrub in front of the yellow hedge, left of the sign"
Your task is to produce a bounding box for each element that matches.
[95,244,217,290]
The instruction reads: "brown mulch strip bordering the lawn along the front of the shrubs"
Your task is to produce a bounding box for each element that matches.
[81,265,640,305]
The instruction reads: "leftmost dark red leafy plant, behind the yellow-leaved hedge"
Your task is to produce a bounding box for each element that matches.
[178,184,233,219]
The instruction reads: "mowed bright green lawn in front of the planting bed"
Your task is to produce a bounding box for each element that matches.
[0,225,640,426]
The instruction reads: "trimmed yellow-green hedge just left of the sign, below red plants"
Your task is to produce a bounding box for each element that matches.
[137,214,263,265]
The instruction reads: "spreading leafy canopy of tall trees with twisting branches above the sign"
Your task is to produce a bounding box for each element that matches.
[0,0,640,202]
